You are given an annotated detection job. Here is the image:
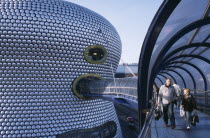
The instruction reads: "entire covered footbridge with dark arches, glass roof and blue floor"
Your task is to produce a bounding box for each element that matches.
[138,0,210,137]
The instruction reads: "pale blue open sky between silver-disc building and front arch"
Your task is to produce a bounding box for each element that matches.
[67,0,162,63]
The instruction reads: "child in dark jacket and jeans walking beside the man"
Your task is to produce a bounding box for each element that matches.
[181,89,197,130]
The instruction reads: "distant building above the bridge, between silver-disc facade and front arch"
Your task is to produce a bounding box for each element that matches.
[115,63,138,78]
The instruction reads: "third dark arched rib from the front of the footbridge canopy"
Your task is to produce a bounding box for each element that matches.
[162,43,210,63]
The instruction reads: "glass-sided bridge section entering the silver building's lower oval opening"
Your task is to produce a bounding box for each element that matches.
[83,77,138,101]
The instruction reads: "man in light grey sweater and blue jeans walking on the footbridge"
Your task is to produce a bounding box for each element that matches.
[158,78,176,129]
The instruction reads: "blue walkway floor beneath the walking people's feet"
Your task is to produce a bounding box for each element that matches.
[151,110,210,138]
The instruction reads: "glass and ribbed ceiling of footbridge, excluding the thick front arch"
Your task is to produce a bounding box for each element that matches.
[148,0,210,91]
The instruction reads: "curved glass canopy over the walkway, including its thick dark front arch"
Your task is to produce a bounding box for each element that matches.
[138,0,210,128]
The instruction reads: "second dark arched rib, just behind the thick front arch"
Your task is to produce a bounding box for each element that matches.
[149,17,210,96]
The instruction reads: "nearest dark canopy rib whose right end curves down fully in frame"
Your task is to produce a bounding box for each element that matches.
[166,61,208,91]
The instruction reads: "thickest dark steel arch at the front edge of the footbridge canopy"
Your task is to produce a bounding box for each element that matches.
[138,0,181,129]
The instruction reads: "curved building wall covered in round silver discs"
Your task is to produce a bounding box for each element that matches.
[0,0,121,137]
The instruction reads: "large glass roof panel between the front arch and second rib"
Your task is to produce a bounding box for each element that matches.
[150,0,208,67]
